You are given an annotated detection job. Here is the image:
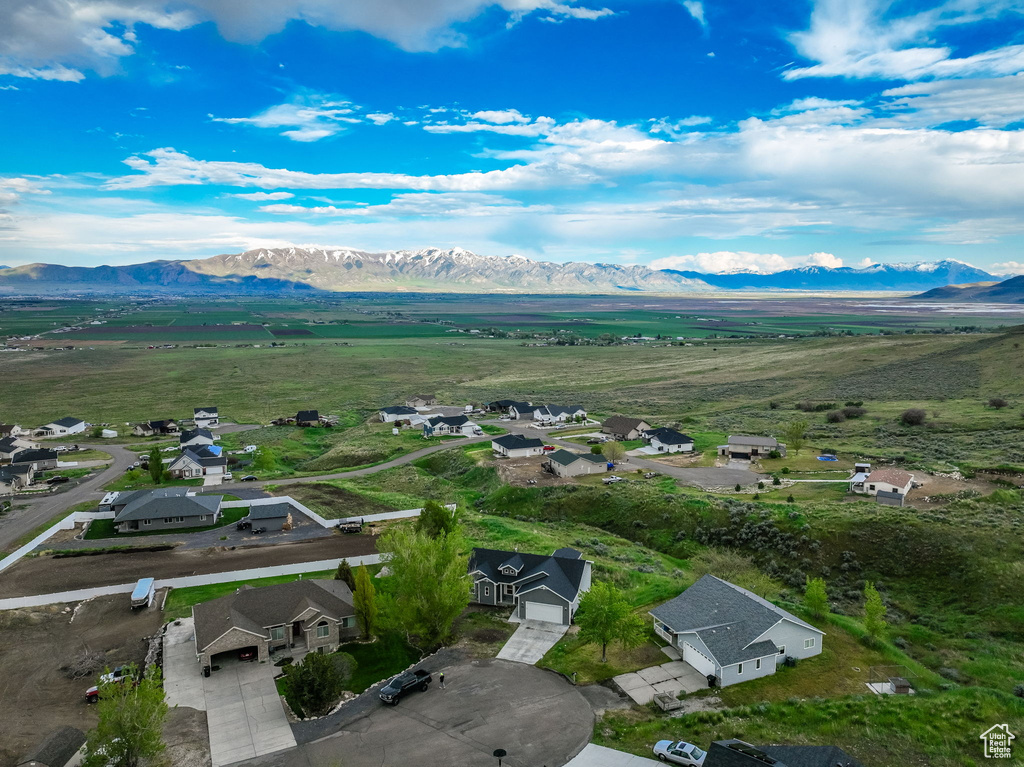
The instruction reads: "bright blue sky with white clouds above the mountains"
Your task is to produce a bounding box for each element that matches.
[0,0,1024,273]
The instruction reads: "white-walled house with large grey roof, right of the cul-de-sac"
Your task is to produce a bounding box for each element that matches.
[650,574,824,687]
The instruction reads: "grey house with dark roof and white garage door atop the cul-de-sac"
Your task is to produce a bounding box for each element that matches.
[469,548,594,626]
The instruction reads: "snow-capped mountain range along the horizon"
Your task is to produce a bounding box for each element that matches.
[0,247,995,294]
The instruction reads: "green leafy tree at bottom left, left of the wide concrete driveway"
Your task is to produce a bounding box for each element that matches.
[83,666,167,767]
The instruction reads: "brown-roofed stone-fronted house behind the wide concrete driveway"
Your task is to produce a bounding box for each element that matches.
[193,580,358,667]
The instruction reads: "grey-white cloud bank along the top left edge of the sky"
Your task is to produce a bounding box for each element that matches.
[0,0,611,82]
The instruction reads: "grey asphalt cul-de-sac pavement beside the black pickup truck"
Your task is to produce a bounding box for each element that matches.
[233,658,594,767]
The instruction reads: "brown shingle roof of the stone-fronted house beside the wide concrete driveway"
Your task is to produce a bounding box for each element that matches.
[193,580,354,651]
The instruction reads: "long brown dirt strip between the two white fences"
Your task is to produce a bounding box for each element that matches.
[0,536,377,598]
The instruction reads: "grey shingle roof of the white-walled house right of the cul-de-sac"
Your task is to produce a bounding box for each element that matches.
[650,576,823,666]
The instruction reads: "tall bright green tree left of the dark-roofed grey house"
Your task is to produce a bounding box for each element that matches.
[377,526,472,648]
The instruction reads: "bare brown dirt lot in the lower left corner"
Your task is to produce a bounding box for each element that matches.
[0,594,162,767]
